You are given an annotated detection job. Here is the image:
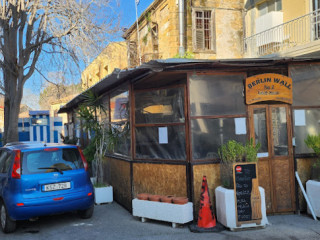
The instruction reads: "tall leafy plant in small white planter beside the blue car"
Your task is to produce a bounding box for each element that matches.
[78,91,114,204]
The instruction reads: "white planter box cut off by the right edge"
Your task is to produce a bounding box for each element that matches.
[306,180,320,217]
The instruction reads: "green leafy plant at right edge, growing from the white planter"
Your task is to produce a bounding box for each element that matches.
[304,134,320,182]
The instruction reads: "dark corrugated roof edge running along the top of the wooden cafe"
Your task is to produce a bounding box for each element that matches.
[58,57,320,113]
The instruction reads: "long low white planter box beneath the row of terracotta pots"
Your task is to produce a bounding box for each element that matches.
[132,199,193,227]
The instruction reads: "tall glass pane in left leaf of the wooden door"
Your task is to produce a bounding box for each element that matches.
[253,108,269,157]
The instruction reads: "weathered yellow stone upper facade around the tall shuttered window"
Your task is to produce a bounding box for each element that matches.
[123,0,244,66]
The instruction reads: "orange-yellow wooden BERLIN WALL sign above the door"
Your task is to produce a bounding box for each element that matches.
[246,73,292,104]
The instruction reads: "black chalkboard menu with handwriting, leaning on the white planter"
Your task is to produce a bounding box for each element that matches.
[233,163,259,224]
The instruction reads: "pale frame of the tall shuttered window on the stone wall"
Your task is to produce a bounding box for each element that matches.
[192,8,216,53]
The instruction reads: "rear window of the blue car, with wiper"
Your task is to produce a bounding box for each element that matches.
[21,148,83,175]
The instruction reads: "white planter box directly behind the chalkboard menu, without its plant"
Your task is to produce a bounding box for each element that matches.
[215,186,268,231]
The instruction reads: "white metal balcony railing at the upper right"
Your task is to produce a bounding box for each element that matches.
[244,9,320,57]
